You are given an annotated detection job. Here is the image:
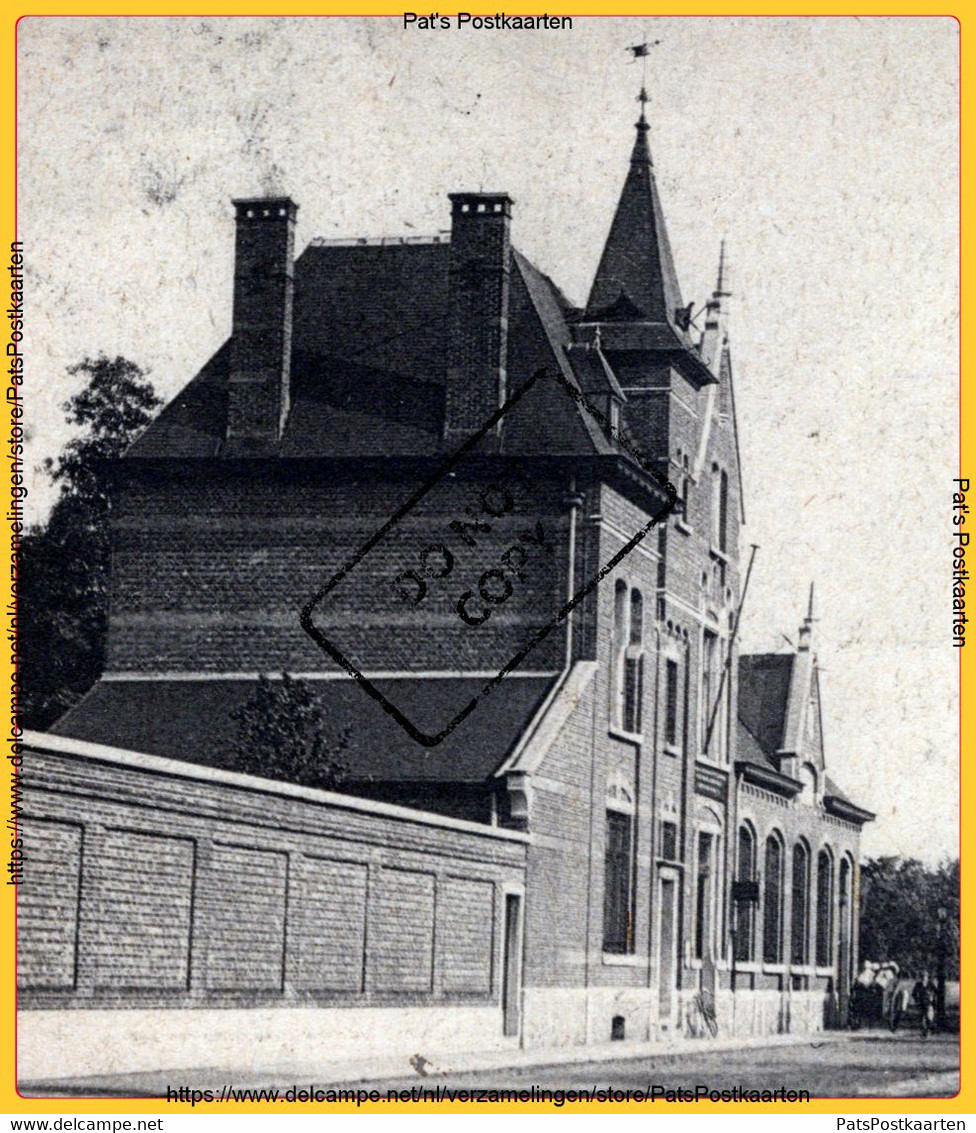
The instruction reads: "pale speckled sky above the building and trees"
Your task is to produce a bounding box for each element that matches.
[19,17,961,861]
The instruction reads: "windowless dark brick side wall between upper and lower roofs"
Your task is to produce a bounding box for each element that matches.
[107,466,568,672]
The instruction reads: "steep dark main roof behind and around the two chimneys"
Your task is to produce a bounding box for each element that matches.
[128,238,616,458]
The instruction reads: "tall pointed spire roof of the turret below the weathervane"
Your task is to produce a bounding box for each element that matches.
[586,118,693,349]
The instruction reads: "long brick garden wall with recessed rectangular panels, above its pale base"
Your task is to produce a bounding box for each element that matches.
[18,740,525,1008]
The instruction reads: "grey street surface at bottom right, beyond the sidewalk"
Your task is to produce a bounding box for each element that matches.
[351,1032,959,1098]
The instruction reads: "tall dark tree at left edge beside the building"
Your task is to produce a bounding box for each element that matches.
[18,355,161,729]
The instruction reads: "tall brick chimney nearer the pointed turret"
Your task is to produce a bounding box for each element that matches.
[444,193,512,440]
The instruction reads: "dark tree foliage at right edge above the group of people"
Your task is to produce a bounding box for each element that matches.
[860,858,959,979]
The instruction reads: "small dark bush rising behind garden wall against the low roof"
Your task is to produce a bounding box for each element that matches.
[234,673,349,790]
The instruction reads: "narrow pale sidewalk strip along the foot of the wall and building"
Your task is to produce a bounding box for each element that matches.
[19,1031,866,1098]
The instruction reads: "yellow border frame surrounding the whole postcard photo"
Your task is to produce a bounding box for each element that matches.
[0,0,976,1116]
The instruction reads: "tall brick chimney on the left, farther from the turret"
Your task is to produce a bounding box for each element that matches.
[227,197,298,448]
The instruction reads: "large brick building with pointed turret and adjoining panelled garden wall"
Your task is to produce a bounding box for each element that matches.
[20,99,873,1076]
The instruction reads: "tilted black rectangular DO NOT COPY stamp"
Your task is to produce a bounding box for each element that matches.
[300,368,677,748]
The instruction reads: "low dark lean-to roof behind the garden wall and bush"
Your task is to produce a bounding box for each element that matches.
[51,676,555,783]
